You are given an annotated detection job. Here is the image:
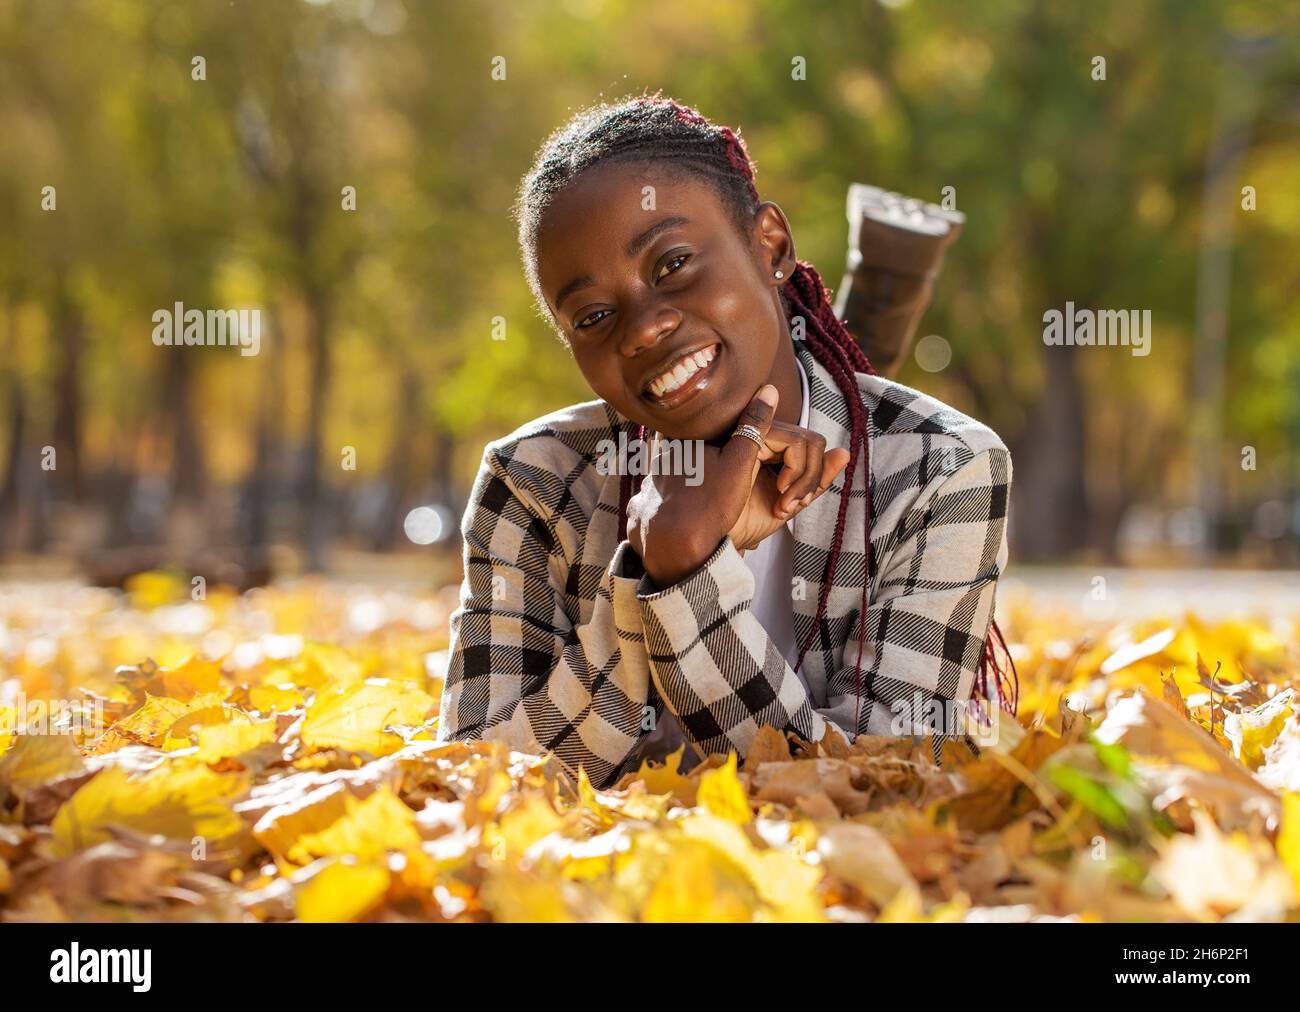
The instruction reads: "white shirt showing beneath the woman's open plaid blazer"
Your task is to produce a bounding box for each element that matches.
[645,356,809,770]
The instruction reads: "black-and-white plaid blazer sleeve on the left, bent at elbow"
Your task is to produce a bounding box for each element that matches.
[438,446,649,786]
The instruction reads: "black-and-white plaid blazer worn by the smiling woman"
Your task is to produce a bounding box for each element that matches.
[438,342,1011,786]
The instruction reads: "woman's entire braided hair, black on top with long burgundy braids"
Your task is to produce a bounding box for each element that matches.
[512,92,1019,734]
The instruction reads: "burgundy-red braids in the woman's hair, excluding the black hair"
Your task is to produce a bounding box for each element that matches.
[527,95,1019,734]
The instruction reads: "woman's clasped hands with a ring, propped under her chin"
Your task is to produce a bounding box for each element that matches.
[628,384,849,587]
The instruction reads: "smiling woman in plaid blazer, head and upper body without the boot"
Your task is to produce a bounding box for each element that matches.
[438,96,1014,786]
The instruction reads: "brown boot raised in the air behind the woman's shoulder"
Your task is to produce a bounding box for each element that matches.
[835,182,966,376]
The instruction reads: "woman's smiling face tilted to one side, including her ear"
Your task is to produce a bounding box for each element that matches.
[537,163,798,440]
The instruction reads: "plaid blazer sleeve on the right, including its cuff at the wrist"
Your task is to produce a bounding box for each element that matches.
[638,447,1011,761]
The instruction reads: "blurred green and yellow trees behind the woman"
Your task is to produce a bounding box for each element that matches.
[0,0,1300,583]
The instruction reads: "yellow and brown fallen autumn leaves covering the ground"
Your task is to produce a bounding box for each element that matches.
[0,574,1300,921]
